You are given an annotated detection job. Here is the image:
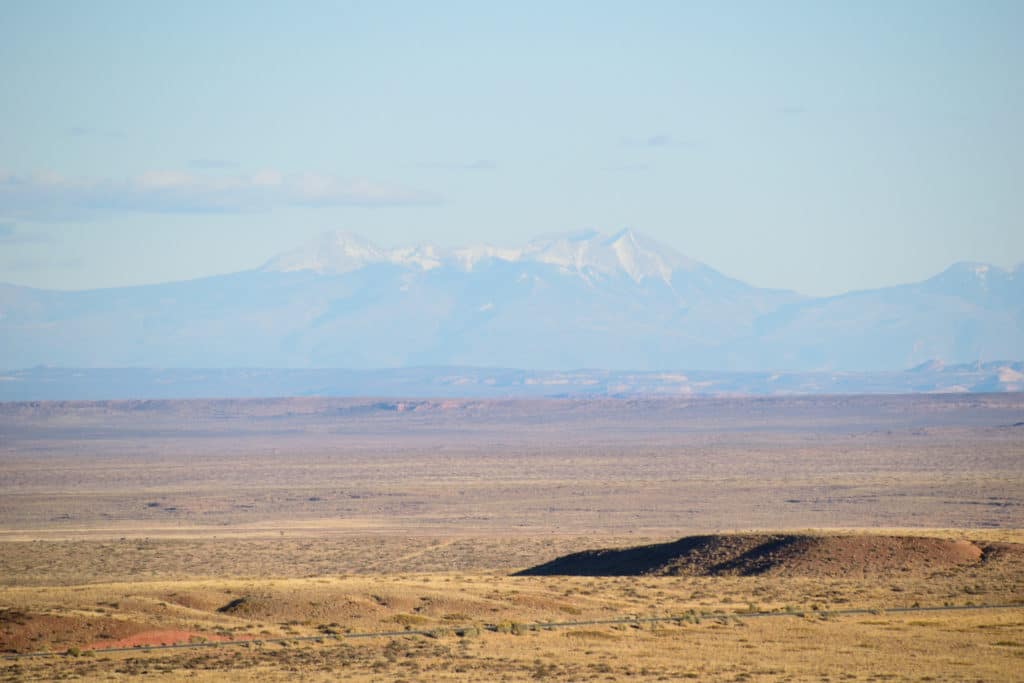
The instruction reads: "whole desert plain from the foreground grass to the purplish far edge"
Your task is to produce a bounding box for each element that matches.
[0,394,1024,681]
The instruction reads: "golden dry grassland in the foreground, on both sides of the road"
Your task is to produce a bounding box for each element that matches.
[2,573,1024,681]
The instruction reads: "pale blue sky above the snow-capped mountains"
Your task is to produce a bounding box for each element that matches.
[0,0,1024,294]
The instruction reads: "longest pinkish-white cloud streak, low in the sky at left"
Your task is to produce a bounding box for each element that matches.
[0,170,439,219]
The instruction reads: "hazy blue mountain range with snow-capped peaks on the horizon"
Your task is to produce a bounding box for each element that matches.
[0,230,1024,373]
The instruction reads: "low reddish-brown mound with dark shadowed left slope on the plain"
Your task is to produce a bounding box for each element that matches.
[517,533,1024,577]
